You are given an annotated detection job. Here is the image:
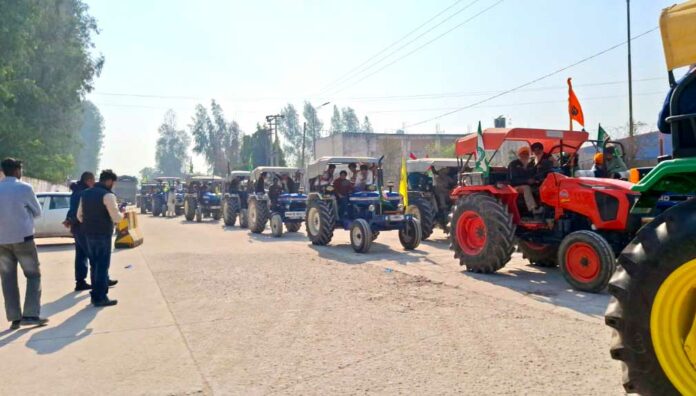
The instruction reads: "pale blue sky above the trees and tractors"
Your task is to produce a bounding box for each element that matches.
[88,0,674,174]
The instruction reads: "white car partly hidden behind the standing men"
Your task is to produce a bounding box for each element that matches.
[34,192,72,238]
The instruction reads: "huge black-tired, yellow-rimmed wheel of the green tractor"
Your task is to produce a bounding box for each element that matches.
[604,200,696,395]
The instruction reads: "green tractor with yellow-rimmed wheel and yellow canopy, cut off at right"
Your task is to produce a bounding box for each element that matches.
[605,0,696,395]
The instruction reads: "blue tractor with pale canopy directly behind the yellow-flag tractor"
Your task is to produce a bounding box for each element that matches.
[247,166,307,237]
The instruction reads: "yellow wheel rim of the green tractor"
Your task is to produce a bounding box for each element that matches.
[650,259,696,395]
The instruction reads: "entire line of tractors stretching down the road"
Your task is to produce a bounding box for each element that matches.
[132,1,696,395]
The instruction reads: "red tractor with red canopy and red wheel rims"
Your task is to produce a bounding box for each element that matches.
[450,128,641,292]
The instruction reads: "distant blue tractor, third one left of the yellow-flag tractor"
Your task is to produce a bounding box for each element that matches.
[184,176,223,223]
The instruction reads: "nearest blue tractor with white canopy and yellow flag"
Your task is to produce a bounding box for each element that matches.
[305,157,422,253]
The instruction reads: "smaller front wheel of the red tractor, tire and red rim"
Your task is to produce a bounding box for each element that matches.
[558,230,616,293]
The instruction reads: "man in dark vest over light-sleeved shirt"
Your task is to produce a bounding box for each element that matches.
[77,169,123,307]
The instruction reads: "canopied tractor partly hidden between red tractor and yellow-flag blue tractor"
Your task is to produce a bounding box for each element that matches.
[406,158,459,240]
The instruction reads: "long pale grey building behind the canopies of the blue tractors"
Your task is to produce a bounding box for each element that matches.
[314,132,465,184]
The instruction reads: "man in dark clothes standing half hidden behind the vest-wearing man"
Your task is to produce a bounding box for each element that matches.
[63,172,94,291]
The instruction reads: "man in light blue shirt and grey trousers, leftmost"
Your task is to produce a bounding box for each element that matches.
[0,158,48,330]
